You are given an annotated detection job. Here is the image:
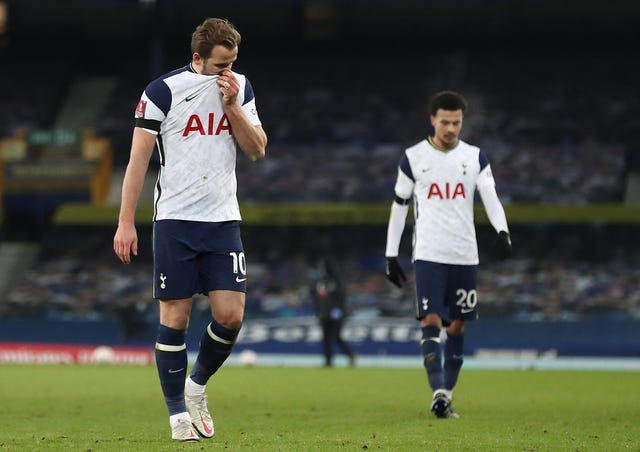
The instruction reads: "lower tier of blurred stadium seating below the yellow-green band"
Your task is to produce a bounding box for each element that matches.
[1,225,640,322]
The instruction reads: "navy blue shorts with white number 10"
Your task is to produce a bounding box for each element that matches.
[153,220,247,300]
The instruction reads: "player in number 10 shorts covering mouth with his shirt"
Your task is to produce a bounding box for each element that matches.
[113,18,267,441]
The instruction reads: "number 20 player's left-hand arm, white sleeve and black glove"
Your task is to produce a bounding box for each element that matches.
[384,161,414,287]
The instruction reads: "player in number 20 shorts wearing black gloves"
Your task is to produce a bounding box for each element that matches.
[385,91,511,418]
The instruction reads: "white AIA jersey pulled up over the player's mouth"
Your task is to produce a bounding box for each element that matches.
[135,65,261,222]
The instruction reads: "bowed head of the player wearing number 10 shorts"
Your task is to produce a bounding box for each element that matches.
[191,17,241,75]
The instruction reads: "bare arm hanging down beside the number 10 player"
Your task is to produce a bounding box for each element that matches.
[113,127,156,264]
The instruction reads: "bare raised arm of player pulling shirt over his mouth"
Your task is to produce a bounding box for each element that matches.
[217,69,267,161]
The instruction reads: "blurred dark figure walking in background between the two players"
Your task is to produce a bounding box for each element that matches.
[312,258,356,367]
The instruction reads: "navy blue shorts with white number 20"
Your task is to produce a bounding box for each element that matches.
[414,261,478,320]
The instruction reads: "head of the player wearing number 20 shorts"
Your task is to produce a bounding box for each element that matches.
[427,91,467,149]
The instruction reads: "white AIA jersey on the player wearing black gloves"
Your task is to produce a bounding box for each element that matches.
[395,140,495,265]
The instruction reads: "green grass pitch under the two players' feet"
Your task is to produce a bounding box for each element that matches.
[0,365,640,451]
